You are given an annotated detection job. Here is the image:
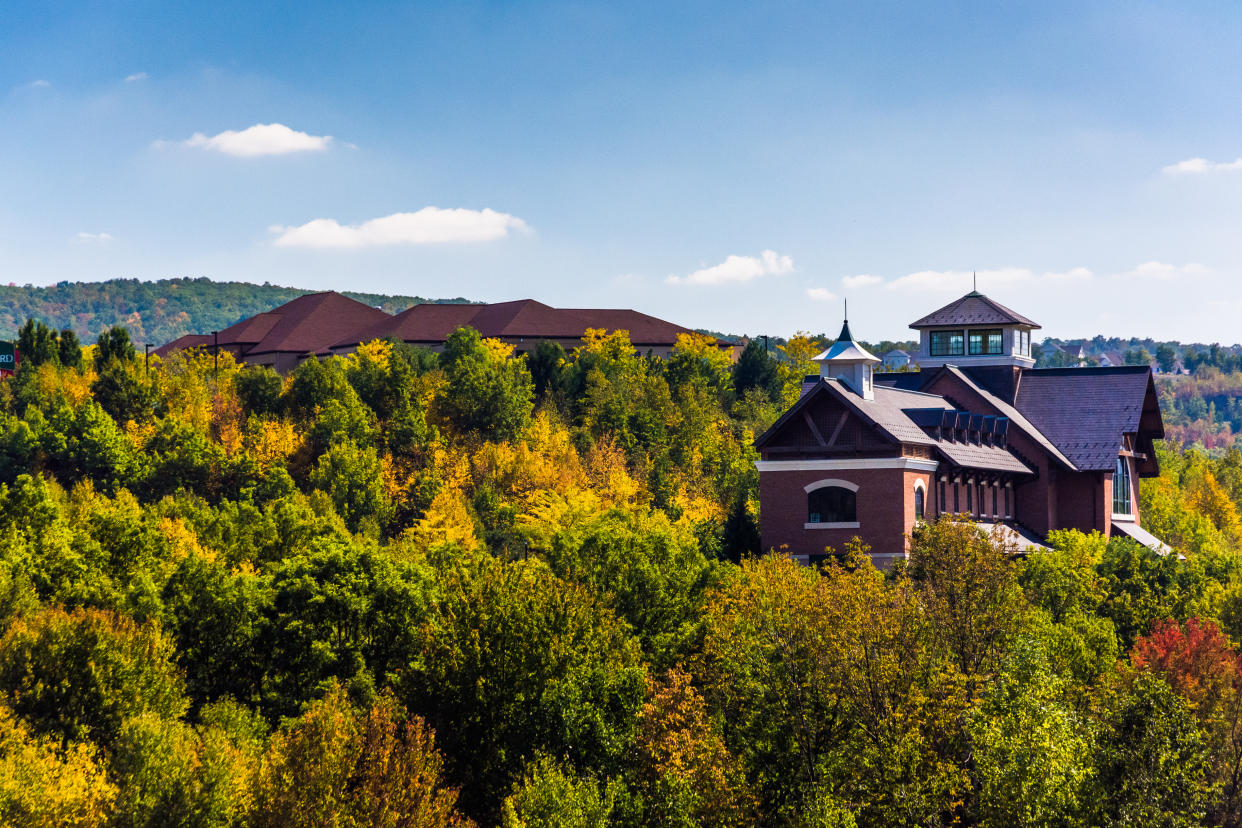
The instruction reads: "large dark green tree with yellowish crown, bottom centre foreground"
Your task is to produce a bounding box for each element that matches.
[402,549,645,819]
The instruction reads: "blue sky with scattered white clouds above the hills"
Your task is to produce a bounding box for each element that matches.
[0,0,1242,344]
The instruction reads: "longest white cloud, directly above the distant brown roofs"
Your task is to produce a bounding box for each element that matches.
[268,207,530,248]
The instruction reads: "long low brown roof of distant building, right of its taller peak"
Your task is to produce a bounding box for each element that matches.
[334,299,710,348]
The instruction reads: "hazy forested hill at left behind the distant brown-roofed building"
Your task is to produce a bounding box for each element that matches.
[0,278,466,345]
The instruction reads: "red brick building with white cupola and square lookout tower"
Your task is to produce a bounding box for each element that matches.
[755,292,1165,566]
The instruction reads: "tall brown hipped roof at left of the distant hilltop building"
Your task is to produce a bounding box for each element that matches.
[220,290,391,356]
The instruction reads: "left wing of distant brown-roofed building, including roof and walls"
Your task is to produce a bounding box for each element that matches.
[155,290,392,372]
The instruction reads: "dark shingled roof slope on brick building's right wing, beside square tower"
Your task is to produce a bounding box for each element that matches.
[1017,365,1164,472]
